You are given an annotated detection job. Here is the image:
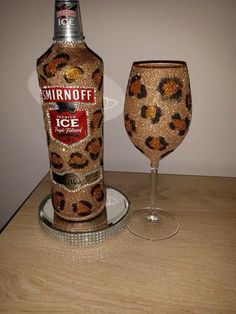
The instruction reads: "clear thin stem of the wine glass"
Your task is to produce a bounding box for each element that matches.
[147,167,159,223]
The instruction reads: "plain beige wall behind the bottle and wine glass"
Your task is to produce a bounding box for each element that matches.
[0,0,236,227]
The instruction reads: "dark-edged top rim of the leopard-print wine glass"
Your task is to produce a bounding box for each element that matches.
[132,60,187,69]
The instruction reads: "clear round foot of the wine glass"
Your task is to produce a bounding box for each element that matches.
[127,208,179,240]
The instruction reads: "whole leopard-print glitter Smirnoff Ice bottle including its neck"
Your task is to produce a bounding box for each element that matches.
[37,0,106,221]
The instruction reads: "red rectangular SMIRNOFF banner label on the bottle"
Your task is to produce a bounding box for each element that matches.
[41,87,95,103]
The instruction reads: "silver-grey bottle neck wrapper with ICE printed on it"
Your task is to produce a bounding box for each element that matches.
[53,0,84,42]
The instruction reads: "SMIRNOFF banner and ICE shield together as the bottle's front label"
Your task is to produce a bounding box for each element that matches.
[41,86,96,146]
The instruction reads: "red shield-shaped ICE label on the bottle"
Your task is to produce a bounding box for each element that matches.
[49,110,88,145]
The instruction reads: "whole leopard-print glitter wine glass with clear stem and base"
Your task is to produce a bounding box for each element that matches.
[124,61,192,240]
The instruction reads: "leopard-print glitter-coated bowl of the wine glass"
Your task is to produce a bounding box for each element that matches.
[124,61,192,167]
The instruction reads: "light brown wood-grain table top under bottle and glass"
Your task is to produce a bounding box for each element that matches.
[0,172,236,314]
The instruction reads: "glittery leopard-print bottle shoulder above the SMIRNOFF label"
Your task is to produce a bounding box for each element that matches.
[37,43,103,91]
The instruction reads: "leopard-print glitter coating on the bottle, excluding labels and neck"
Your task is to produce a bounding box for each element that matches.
[37,42,106,221]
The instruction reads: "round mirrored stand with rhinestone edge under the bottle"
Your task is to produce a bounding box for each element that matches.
[39,187,129,245]
